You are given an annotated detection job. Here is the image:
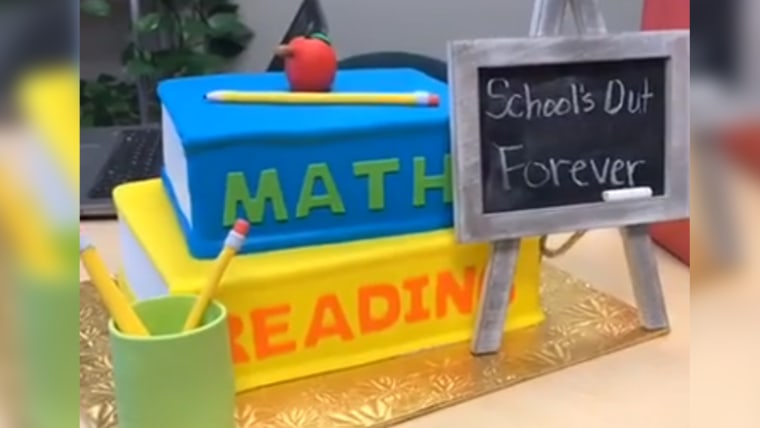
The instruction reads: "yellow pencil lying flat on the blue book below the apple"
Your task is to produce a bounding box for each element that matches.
[205,90,440,107]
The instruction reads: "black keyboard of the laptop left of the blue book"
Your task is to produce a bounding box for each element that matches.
[88,129,163,199]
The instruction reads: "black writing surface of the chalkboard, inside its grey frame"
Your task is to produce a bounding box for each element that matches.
[478,58,668,213]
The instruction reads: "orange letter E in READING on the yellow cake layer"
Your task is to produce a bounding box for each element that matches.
[251,305,296,360]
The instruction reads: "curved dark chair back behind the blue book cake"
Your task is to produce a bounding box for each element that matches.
[338,52,447,83]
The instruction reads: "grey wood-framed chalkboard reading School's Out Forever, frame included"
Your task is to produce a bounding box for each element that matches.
[448,30,690,242]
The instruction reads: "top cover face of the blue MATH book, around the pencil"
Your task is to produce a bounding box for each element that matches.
[158,69,448,152]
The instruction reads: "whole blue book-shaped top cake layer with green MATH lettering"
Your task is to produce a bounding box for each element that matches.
[161,70,452,258]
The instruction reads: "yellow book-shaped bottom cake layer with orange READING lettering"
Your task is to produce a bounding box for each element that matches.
[115,180,544,390]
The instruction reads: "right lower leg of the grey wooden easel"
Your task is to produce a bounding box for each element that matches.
[620,224,668,330]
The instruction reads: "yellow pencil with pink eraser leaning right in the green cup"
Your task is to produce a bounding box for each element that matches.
[183,219,250,331]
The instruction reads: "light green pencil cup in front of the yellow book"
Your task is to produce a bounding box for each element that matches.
[109,296,235,428]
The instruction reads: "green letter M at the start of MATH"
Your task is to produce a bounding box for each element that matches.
[224,169,288,228]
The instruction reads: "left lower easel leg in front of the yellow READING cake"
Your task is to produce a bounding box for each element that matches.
[470,239,520,355]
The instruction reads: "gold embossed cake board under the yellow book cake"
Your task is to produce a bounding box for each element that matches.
[79,264,667,428]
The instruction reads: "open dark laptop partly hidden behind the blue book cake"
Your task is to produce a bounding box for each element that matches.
[79,0,327,219]
